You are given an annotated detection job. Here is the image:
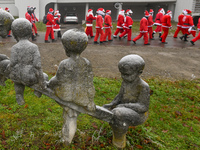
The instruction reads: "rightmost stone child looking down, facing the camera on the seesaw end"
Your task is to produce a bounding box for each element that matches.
[103,55,150,148]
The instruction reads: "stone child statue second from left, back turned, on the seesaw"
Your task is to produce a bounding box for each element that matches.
[9,18,46,105]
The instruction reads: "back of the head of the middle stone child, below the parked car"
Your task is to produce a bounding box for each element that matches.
[61,29,88,57]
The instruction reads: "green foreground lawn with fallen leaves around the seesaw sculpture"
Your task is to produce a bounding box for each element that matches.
[0,77,200,150]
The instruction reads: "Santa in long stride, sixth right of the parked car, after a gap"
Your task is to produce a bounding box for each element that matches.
[133,10,150,45]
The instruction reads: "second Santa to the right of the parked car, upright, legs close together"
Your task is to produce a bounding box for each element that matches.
[94,8,105,44]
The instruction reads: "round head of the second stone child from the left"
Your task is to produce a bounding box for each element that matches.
[11,18,32,41]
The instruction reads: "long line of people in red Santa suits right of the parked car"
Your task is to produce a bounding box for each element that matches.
[85,8,200,45]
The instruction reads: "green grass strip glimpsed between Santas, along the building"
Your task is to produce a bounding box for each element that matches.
[36,21,177,34]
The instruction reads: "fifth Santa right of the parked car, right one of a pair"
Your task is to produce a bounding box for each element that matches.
[119,9,133,41]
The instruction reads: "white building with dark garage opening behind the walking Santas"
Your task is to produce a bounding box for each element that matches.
[0,0,200,21]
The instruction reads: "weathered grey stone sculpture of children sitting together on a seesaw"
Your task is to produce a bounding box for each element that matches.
[0,18,150,148]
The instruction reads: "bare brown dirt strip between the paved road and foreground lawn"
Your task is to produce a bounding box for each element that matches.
[0,42,200,79]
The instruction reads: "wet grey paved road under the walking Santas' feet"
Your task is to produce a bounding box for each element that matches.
[0,24,200,48]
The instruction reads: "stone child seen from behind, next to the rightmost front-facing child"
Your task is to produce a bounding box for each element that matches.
[49,29,96,145]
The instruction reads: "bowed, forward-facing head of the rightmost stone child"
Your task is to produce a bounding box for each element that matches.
[118,54,145,82]
